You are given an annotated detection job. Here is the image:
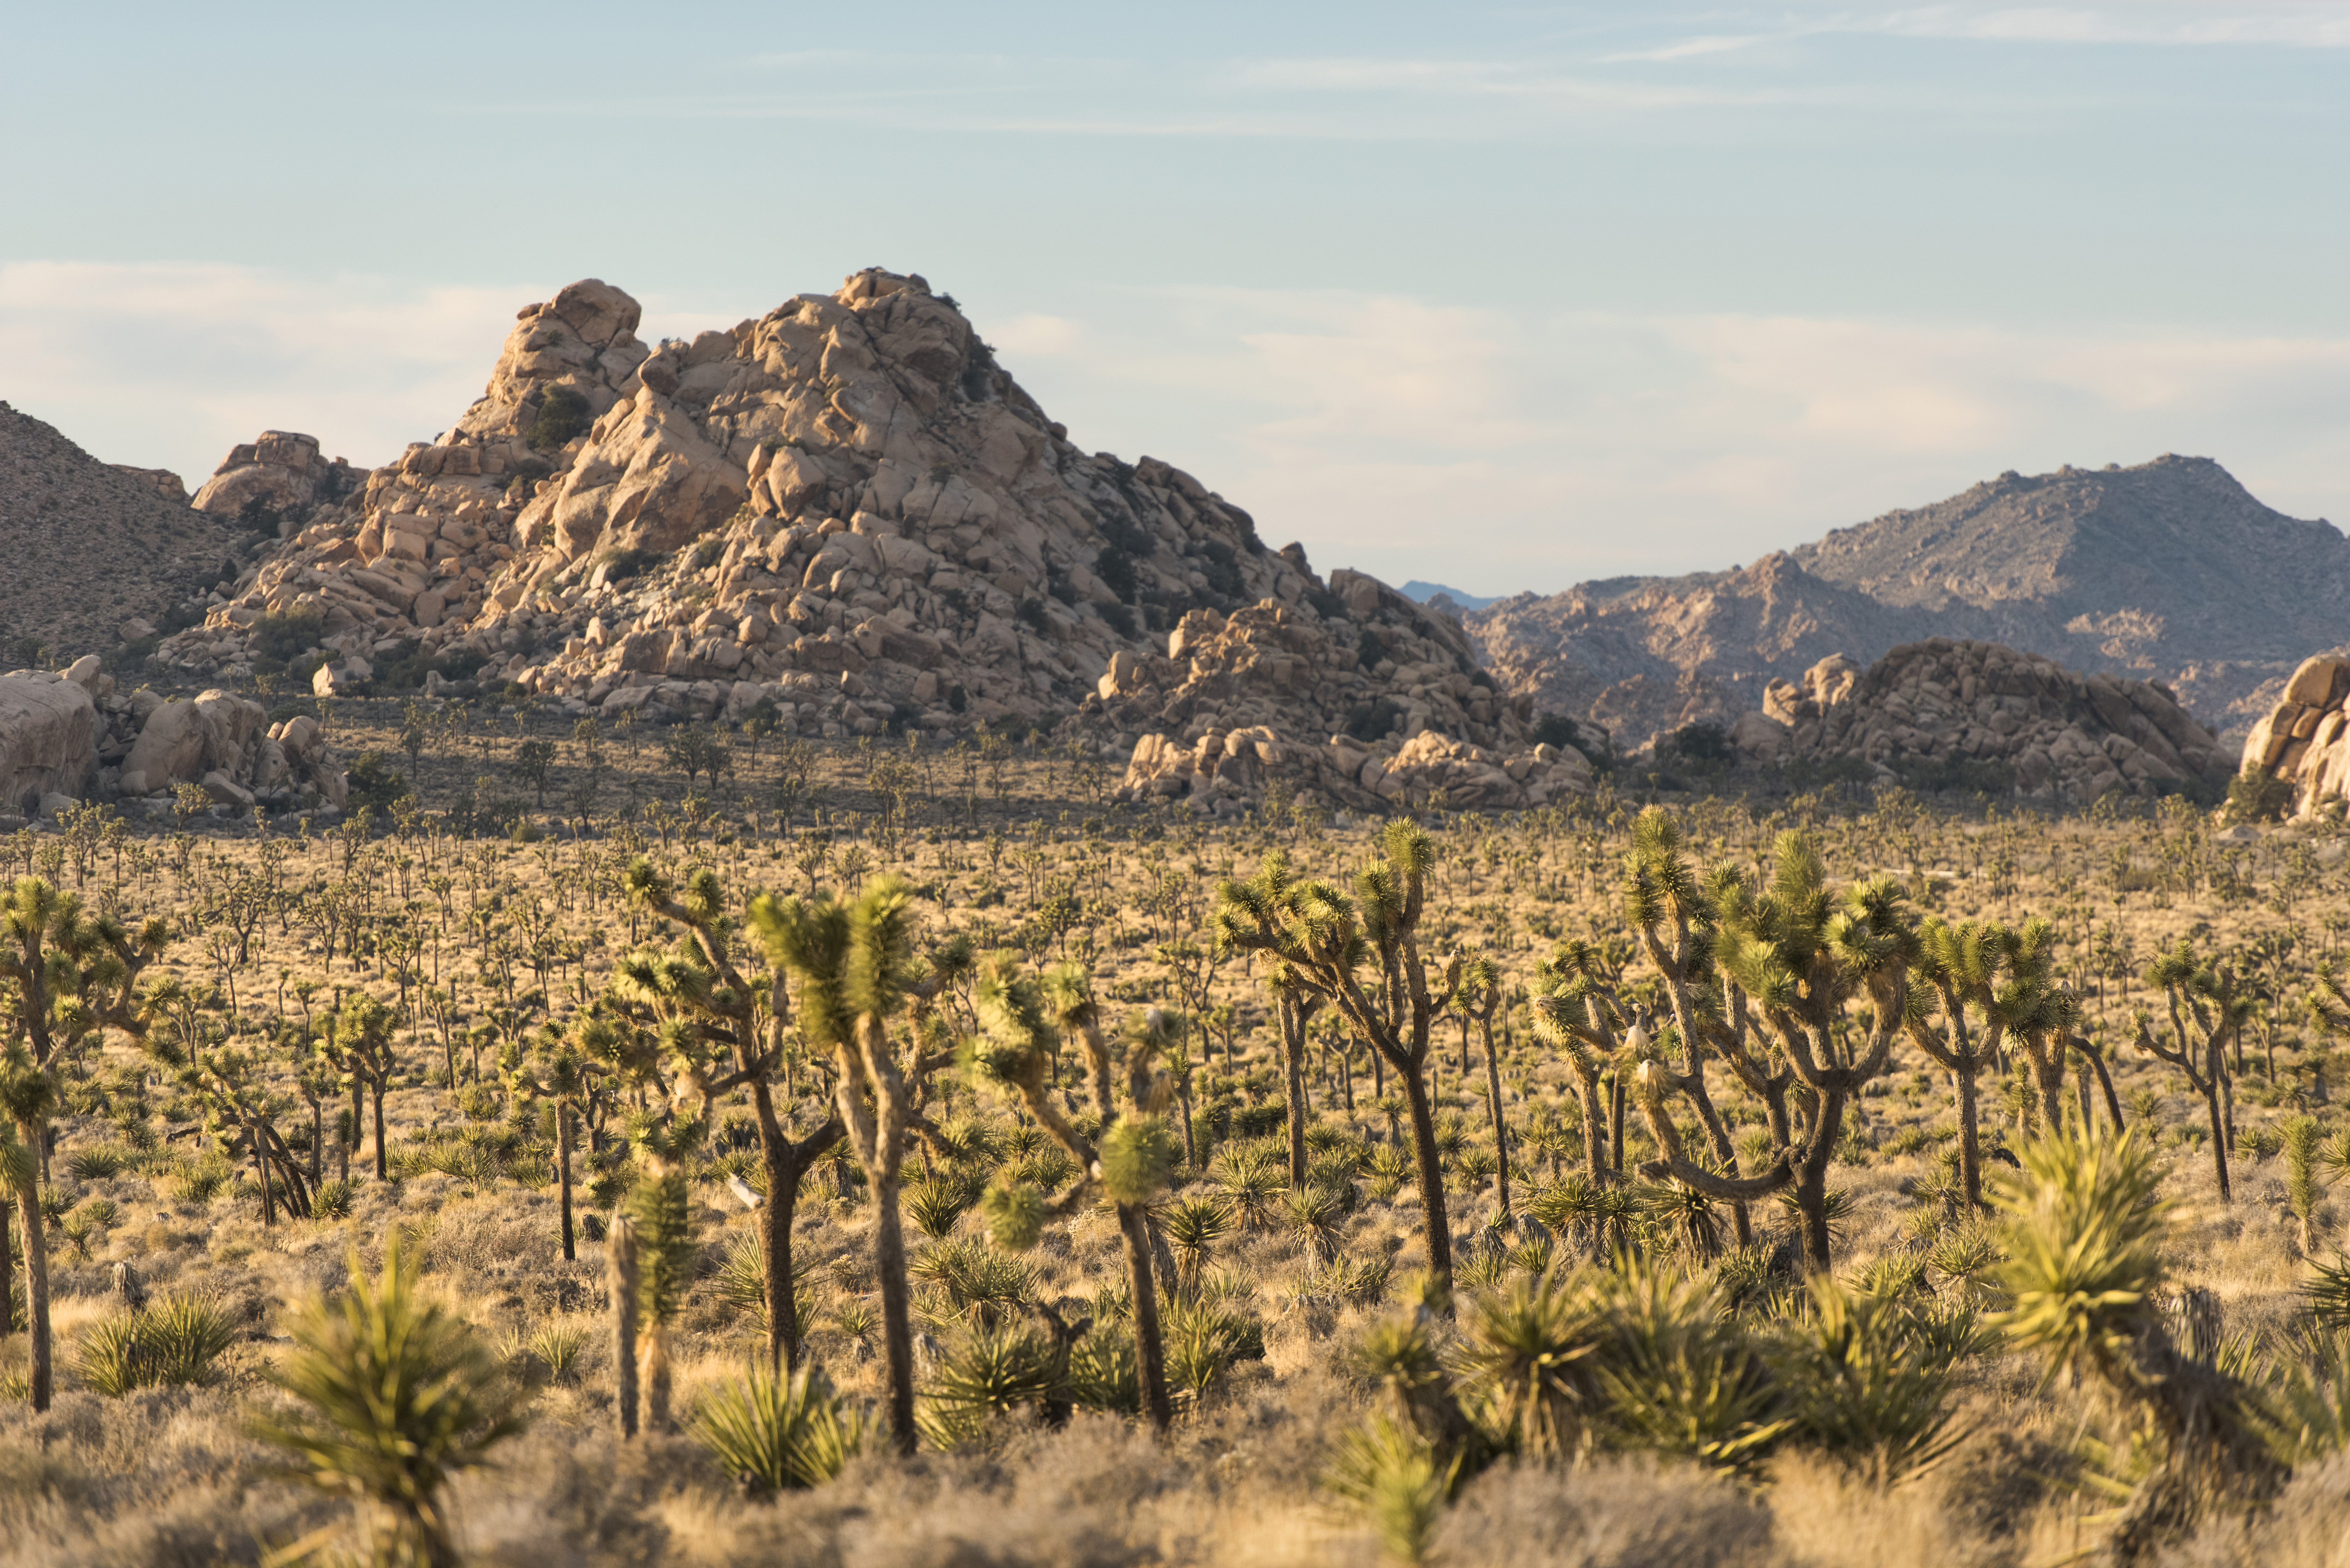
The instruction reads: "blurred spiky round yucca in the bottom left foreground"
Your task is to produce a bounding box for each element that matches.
[252,1232,524,1568]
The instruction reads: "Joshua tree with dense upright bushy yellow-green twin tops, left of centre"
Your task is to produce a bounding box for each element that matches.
[750,877,961,1453]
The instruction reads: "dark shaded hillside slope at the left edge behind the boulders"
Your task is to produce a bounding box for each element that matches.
[0,402,254,667]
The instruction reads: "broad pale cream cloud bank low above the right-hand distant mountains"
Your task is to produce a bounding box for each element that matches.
[1013,291,2350,592]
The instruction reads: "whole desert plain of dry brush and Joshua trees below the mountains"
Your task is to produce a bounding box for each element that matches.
[18,705,2350,1563]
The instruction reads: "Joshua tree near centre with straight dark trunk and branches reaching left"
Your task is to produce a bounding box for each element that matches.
[1215,818,1462,1281]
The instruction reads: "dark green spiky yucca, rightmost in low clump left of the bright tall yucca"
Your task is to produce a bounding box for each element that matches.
[1777,1274,1962,1488]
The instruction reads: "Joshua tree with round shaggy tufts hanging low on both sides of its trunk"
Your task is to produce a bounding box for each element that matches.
[971,959,1175,1427]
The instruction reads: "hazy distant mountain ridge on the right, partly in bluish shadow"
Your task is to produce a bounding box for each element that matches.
[1467,456,2350,748]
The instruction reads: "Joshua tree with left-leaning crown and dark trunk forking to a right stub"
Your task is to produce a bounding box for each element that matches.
[625,860,846,1368]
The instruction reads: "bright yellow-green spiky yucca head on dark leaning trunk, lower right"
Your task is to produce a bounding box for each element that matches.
[1995,1128,2282,1561]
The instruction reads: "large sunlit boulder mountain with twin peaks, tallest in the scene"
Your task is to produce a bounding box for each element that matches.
[162,270,1528,776]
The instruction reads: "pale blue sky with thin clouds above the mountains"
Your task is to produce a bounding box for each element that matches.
[0,0,2350,595]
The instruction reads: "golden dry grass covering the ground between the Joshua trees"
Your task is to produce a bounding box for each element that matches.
[0,703,2350,1568]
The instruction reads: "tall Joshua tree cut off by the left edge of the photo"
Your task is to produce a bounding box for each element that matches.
[0,877,169,1411]
